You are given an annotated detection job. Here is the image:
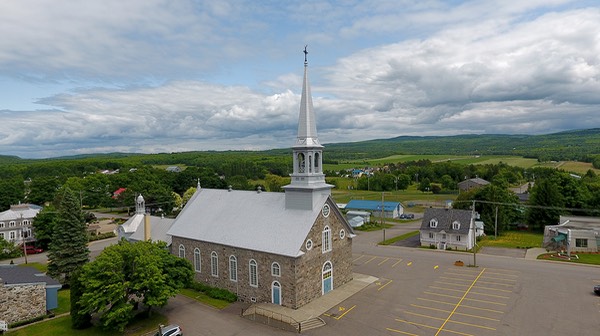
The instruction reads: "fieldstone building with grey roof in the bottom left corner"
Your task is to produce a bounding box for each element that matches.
[0,265,62,324]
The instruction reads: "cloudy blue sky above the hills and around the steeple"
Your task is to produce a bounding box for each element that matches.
[0,0,600,158]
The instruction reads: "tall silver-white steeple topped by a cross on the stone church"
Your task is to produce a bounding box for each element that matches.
[283,47,333,209]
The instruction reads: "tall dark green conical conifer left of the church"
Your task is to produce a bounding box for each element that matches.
[48,188,90,286]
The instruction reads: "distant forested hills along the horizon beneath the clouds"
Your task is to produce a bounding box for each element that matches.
[0,128,600,164]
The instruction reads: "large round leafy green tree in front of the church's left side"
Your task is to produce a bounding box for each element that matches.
[79,241,193,331]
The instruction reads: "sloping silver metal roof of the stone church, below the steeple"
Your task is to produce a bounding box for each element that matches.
[167,189,335,257]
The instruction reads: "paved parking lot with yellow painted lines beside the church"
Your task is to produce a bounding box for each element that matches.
[305,247,600,336]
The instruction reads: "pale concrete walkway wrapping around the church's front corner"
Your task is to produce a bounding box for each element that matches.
[243,273,378,322]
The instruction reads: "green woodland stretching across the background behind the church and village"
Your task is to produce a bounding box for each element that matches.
[0,129,600,235]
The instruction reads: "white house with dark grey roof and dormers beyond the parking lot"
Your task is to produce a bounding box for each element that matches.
[419,208,483,251]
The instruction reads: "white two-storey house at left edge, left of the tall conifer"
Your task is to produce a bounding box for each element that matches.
[0,204,42,244]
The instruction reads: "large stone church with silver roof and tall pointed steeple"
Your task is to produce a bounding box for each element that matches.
[167,49,355,309]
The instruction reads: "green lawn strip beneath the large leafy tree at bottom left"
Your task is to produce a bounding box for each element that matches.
[6,312,168,336]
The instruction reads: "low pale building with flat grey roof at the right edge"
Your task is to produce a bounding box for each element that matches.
[543,216,600,253]
